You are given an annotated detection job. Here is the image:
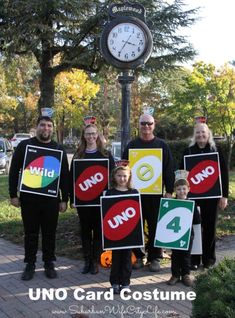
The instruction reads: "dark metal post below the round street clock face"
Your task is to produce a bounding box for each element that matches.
[118,70,135,153]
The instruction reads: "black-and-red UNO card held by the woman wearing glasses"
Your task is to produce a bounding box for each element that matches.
[73,159,109,207]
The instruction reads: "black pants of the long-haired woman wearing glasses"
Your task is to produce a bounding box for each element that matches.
[77,207,102,262]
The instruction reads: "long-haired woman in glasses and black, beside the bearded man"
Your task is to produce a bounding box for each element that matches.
[70,124,114,274]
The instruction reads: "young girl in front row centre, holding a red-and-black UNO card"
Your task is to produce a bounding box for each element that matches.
[106,160,138,294]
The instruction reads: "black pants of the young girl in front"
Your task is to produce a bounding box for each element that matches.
[109,249,132,286]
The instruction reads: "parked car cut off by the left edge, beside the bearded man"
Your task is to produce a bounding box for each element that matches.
[0,138,13,174]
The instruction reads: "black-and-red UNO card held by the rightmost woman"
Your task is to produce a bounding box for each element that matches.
[184,152,222,199]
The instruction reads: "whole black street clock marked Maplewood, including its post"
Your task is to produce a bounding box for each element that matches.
[100,0,153,153]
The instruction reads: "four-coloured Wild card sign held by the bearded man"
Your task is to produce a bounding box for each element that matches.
[20,145,63,197]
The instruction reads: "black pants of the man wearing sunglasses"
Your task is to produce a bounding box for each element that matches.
[133,195,162,262]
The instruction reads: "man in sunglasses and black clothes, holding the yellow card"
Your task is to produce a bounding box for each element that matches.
[123,114,174,272]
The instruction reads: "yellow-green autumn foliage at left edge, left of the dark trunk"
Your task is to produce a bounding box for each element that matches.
[0,56,38,134]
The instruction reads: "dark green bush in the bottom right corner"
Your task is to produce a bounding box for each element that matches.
[192,258,235,318]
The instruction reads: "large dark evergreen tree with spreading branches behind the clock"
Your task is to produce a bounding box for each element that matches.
[0,0,196,112]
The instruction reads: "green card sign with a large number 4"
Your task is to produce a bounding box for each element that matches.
[154,198,195,250]
